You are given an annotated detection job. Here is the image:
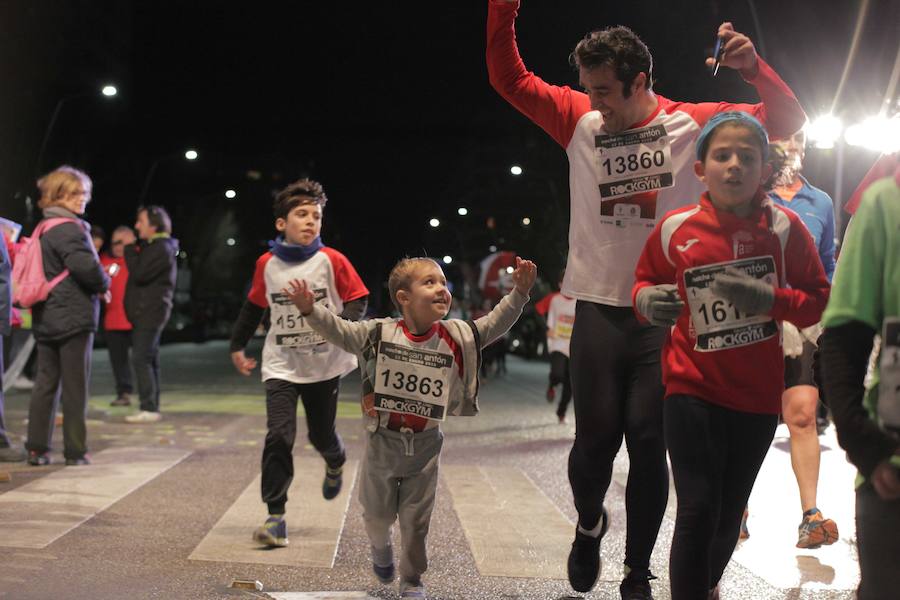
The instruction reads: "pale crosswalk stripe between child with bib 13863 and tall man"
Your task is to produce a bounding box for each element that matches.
[441,465,575,579]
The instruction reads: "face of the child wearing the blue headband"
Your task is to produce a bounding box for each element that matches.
[694,123,772,217]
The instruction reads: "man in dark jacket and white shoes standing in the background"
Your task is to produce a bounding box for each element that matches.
[125,206,178,423]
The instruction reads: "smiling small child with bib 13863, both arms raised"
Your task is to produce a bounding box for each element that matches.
[284,257,537,599]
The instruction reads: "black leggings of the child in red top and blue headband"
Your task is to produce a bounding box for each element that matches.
[664,395,778,600]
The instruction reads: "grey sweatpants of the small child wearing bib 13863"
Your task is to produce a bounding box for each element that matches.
[359,428,444,582]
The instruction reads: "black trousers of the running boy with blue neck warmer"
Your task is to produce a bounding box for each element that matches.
[262,377,346,514]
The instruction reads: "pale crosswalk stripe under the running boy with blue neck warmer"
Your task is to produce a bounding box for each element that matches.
[188,457,359,569]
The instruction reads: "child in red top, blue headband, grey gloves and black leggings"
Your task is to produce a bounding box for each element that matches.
[632,112,828,600]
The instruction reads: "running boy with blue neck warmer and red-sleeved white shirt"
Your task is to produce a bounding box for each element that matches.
[231,179,369,546]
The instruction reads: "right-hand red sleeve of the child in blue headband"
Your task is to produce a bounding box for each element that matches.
[769,211,831,327]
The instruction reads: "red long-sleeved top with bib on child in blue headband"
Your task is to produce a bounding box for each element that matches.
[632,193,829,414]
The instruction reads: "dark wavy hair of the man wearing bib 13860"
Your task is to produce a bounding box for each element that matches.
[569,25,653,98]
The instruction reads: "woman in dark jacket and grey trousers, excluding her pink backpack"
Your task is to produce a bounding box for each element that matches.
[25,166,109,465]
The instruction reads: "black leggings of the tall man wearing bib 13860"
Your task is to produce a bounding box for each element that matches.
[569,300,669,569]
